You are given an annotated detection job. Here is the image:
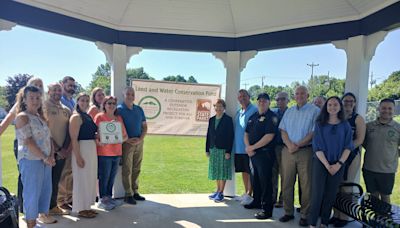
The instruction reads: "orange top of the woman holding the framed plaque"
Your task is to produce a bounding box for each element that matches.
[94,112,127,156]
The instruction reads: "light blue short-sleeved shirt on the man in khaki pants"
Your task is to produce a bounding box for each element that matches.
[279,103,320,143]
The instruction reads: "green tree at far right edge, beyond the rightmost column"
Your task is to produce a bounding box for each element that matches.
[368,71,400,101]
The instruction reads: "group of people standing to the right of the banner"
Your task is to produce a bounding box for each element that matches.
[206,86,400,227]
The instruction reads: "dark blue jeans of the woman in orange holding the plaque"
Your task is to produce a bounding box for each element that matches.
[98,156,121,198]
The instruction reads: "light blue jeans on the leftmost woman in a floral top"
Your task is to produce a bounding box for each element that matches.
[19,159,52,220]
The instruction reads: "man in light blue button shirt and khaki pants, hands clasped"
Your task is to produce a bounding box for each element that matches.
[279,86,319,226]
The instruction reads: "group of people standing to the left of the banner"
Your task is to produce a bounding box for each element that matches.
[0,76,147,228]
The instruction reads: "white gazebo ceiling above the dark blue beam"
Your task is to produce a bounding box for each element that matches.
[13,0,398,37]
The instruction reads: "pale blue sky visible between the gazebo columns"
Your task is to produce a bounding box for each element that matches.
[0,26,400,88]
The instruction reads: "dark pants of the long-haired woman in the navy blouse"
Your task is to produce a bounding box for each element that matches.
[309,158,344,226]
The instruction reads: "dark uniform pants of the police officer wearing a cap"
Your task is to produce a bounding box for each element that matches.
[251,151,275,214]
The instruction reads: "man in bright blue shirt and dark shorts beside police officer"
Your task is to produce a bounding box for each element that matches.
[233,89,257,205]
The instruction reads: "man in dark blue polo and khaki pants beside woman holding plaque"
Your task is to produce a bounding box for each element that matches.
[118,87,147,204]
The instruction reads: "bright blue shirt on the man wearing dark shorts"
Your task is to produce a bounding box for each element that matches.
[232,104,258,154]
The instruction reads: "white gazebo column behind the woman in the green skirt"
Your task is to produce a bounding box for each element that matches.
[212,51,257,196]
